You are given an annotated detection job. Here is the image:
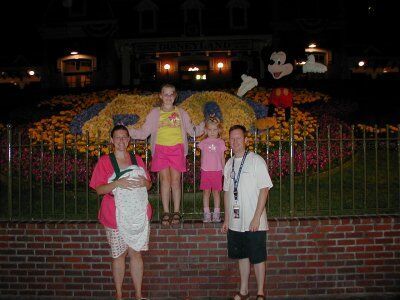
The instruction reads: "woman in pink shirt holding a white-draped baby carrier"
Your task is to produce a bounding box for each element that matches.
[90,125,151,299]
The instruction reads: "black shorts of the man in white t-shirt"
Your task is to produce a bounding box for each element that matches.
[228,229,267,264]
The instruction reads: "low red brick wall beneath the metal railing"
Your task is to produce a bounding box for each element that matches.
[0,216,400,299]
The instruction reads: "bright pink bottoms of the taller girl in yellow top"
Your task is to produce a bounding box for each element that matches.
[151,144,186,172]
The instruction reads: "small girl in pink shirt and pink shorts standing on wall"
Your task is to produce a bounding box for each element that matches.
[198,116,226,223]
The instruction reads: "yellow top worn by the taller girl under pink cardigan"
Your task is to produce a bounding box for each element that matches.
[156,107,183,146]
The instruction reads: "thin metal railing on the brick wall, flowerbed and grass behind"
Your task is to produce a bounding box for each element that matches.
[0,124,400,221]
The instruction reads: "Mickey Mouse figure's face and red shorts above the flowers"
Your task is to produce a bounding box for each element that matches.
[268,51,293,121]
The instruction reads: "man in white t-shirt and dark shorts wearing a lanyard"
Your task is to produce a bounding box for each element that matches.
[221,125,272,300]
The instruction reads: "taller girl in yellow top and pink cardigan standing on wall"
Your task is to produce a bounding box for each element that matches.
[129,84,204,226]
